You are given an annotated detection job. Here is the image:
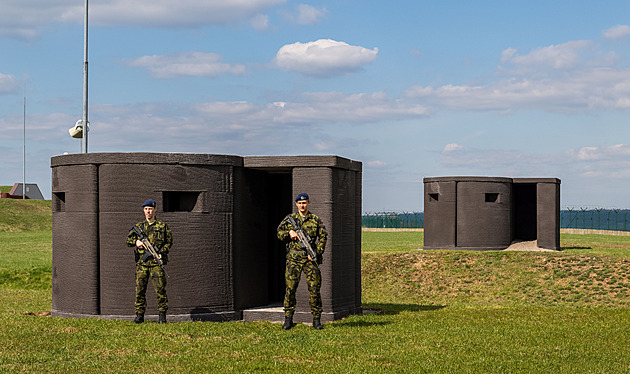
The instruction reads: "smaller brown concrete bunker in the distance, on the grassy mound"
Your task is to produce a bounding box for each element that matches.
[424,177,560,250]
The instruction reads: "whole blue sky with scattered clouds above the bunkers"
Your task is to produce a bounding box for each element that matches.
[0,0,630,213]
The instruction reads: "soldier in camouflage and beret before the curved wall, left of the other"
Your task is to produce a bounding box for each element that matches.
[127,199,173,323]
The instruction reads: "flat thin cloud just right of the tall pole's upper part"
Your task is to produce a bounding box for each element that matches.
[129,52,245,78]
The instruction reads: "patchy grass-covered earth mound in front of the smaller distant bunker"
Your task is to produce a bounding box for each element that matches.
[362,251,630,307]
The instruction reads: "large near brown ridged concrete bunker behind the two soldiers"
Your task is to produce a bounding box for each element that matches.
[51,153,362,322]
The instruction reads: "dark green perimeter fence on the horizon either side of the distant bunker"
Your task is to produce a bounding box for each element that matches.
[361,207,630,231]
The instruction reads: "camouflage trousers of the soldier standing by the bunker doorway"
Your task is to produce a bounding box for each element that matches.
[284,256,322,318]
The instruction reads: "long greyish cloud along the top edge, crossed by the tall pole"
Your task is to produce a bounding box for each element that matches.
[0,0,286,39]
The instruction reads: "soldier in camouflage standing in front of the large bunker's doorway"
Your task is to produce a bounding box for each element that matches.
[278,193,328,330]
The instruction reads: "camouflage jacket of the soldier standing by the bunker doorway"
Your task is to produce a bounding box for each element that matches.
[278,212,328,261]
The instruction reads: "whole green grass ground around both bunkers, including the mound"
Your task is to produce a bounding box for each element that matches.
[0,203,630,373]
